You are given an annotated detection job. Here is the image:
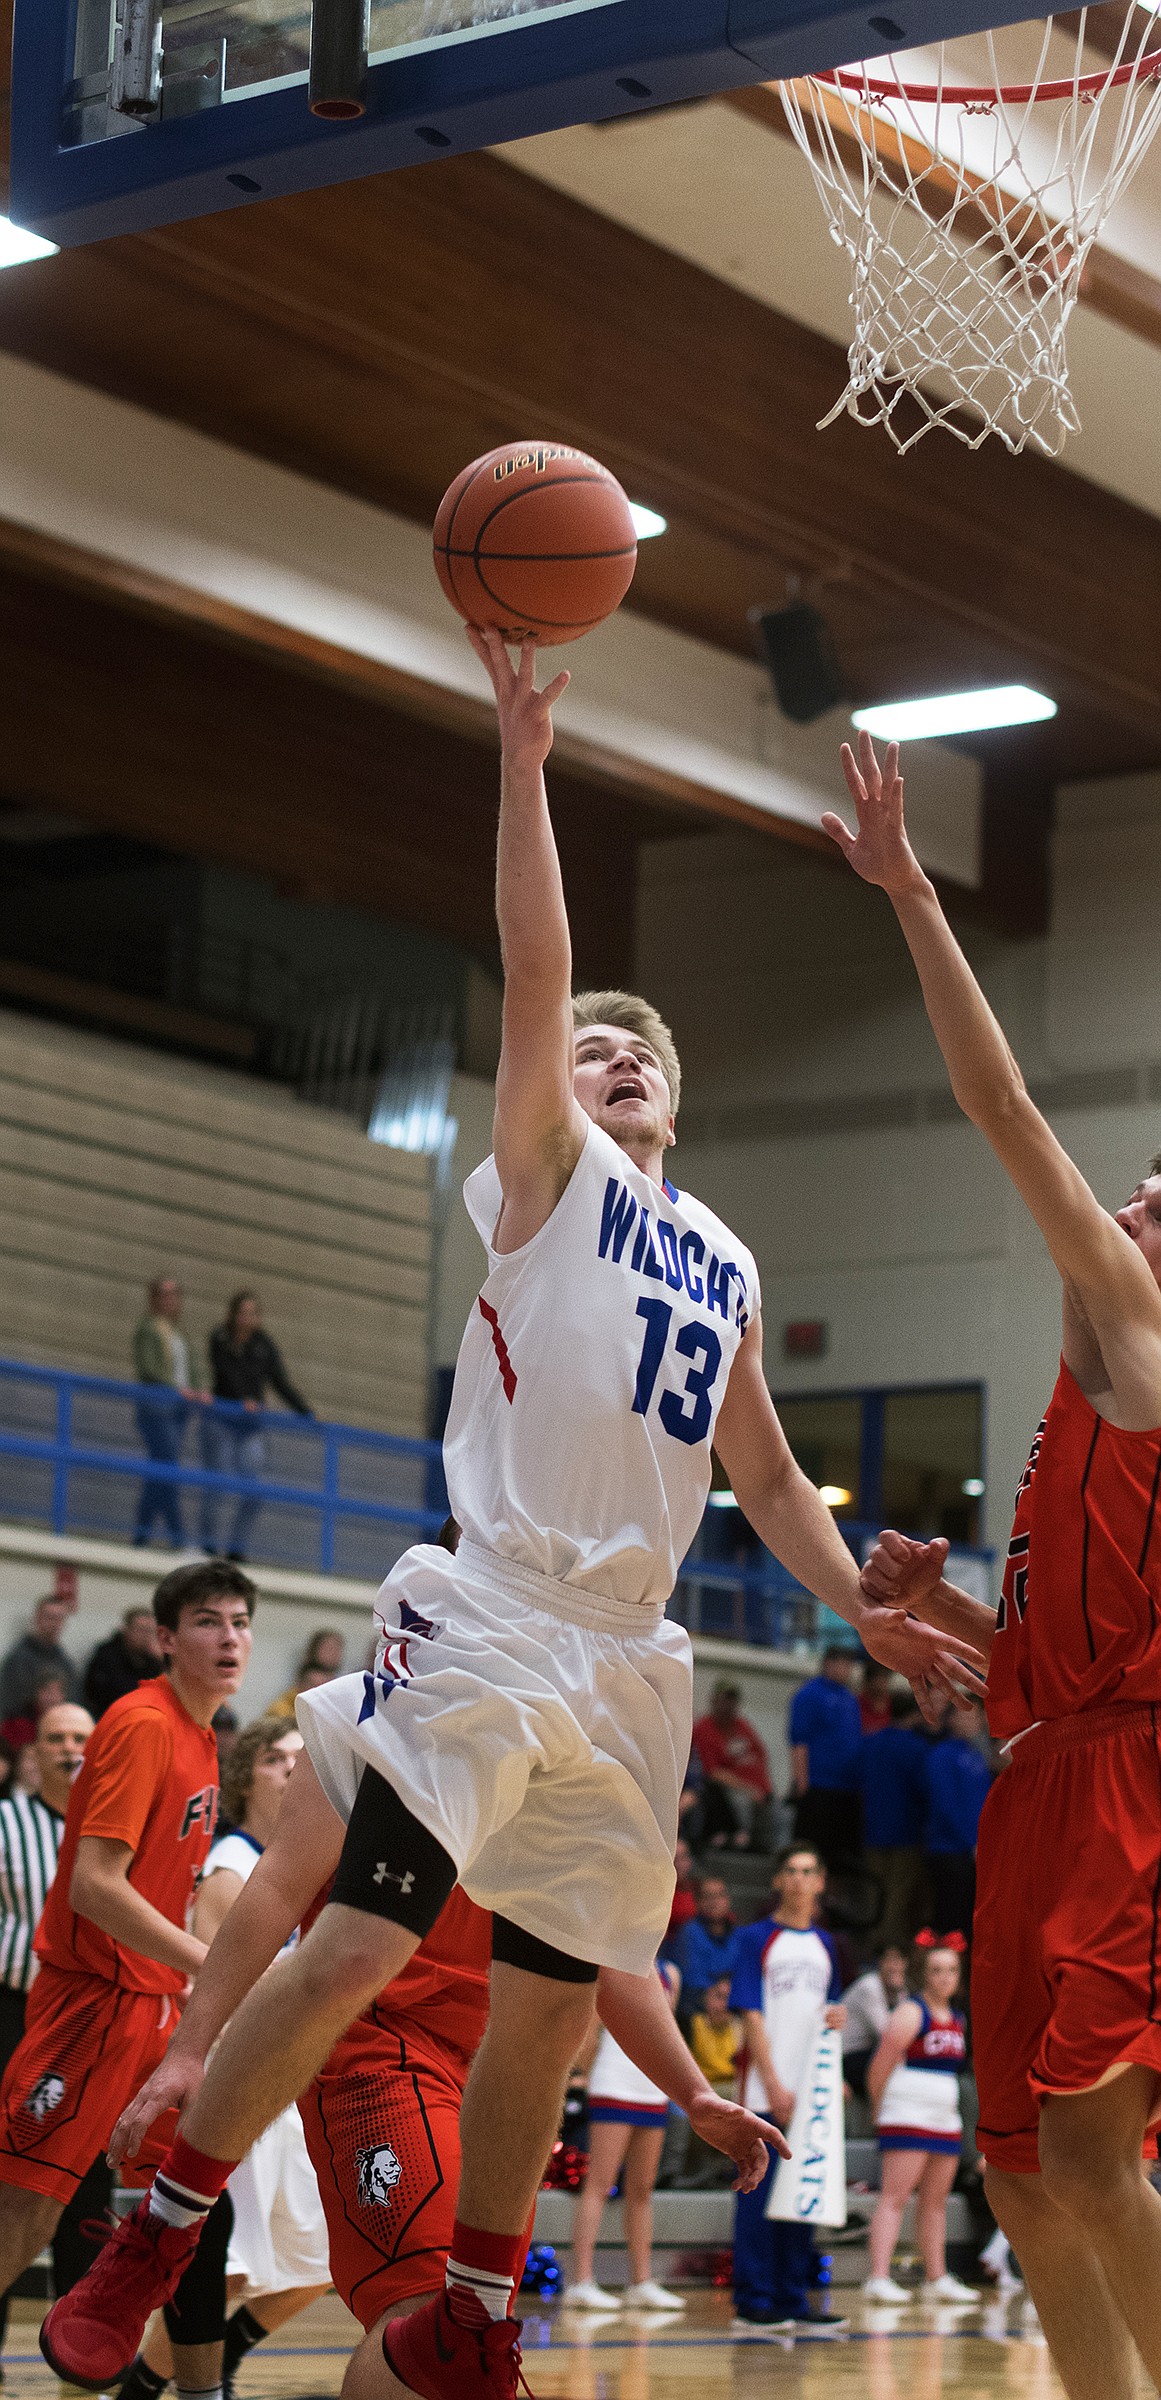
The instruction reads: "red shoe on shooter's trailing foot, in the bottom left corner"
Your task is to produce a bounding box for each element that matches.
[41,2194,201,2393]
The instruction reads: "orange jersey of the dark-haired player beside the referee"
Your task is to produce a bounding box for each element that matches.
[36,1675,218,1992]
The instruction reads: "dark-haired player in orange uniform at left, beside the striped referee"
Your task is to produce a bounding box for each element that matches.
[0,1562,254,2323]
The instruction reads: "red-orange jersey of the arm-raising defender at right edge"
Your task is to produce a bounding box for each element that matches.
[988,1363,1161,1740]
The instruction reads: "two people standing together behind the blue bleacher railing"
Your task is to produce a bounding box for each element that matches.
[132,1274,314,1560]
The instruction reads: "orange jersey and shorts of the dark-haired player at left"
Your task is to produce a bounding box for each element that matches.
[0,1675,218,2201]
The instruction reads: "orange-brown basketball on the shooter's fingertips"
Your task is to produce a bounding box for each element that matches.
[434,442,638,646]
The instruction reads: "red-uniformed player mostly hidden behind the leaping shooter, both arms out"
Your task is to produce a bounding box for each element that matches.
[113,1757,784,2400]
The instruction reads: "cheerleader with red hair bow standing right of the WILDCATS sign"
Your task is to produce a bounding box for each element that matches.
[864,1932,979,2302]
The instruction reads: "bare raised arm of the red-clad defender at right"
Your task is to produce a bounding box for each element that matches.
[823,732,1161,1423]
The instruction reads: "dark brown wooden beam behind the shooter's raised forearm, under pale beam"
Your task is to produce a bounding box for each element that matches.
[0,540,688,984]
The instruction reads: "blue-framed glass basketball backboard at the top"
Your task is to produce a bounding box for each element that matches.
[10,0,1027,245]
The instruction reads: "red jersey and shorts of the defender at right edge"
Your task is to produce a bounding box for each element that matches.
[971,1366,1161,2174]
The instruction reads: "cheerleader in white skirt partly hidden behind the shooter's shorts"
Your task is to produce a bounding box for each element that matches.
[564,1963,686,2314]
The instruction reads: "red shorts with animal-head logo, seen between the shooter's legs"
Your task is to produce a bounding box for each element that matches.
[297,1886,515,2328]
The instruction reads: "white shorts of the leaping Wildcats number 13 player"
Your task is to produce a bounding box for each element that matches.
[297,1541,693,1975]
